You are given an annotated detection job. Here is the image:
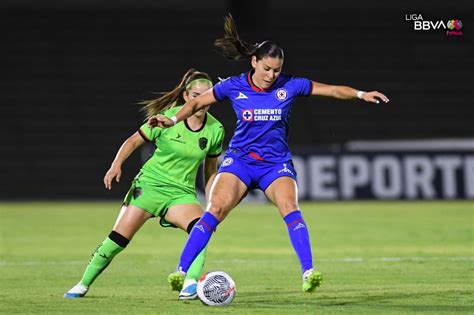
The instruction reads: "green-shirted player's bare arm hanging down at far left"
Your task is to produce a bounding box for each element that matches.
[104,131,145,190]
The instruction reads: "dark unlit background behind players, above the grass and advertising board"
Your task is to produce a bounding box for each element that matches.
[0,0,474,200]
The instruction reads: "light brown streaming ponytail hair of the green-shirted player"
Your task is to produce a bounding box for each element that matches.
[138,69,212,117]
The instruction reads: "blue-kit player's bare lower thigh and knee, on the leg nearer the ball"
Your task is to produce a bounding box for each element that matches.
[207,172,248,221]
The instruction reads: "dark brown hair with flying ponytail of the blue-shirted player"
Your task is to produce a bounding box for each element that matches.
[214,14,283,60]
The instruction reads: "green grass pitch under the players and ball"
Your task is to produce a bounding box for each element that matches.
[0,202,474,314]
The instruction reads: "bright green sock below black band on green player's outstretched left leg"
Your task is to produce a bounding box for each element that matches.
[81,237,125,287]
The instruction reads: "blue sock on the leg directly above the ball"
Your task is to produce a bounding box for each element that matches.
[178,212,219,272]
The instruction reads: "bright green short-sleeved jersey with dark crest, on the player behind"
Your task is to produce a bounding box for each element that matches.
[139,106,224,193]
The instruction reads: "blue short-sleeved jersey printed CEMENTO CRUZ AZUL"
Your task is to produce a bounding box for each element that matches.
[213,72,312,163]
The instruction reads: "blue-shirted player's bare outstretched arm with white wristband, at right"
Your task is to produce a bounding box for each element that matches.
[311,81,389,103]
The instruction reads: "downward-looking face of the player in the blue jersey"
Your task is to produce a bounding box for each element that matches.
[252,56,283,89]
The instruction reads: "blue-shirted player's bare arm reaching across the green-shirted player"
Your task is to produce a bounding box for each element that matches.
[148,88,217,128]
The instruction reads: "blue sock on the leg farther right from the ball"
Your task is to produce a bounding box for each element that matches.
[284,210,313,272]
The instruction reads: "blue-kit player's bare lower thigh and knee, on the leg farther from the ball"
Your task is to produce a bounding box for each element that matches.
[265,176,299,217]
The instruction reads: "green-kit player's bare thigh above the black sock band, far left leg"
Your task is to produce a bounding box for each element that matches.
[113,205,152,240]
